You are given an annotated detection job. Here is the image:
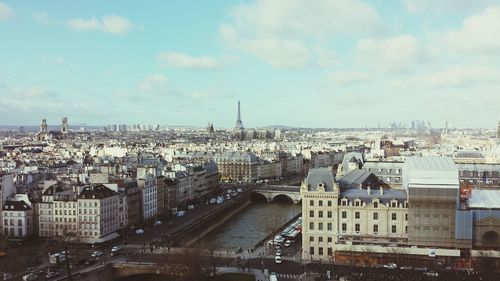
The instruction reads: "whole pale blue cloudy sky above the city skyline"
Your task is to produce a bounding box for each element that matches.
[0,0,500,128]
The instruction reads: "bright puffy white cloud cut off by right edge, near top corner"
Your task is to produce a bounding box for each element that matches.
[435,5,500,55]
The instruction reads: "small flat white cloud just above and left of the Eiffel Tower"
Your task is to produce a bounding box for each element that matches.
[157,52,238,70]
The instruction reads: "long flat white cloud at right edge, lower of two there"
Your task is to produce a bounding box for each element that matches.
[389,65,500,89]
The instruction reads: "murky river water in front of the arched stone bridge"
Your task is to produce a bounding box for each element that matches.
[199,202,301,249]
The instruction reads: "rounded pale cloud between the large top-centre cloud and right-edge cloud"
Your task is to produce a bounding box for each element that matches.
[356,35,435,72]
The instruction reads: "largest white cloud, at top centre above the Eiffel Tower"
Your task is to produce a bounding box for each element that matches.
[219,0,385,68]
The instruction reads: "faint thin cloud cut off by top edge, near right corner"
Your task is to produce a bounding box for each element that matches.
[403,0,495,14]
